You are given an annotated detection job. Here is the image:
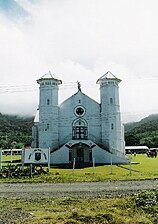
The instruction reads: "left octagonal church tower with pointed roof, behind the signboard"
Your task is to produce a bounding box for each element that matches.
[37,72,62,150]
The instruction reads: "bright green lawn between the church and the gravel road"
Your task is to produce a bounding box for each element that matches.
[0,154,158,183]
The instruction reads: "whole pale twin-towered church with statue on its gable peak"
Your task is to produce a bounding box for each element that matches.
[32,71,127,165]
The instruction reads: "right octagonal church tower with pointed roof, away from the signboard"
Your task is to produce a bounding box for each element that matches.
[97,71,124,155]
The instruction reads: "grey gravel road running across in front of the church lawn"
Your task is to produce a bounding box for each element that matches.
[0,179,158,198]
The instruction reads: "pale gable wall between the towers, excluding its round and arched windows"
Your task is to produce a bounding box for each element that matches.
[59,91,101,145]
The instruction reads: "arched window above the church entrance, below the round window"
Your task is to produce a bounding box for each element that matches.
[72,119,88,139]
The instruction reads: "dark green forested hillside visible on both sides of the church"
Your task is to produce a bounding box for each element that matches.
[0,113,158,148]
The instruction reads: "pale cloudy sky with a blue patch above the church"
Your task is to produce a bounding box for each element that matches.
[0,0,158,123]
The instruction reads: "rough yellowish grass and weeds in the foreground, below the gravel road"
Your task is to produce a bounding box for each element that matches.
[0,190,158,224]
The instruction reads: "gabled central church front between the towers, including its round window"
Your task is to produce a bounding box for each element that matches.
[59,91,101,142]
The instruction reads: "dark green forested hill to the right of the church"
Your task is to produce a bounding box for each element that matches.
[124,114,158,148]
